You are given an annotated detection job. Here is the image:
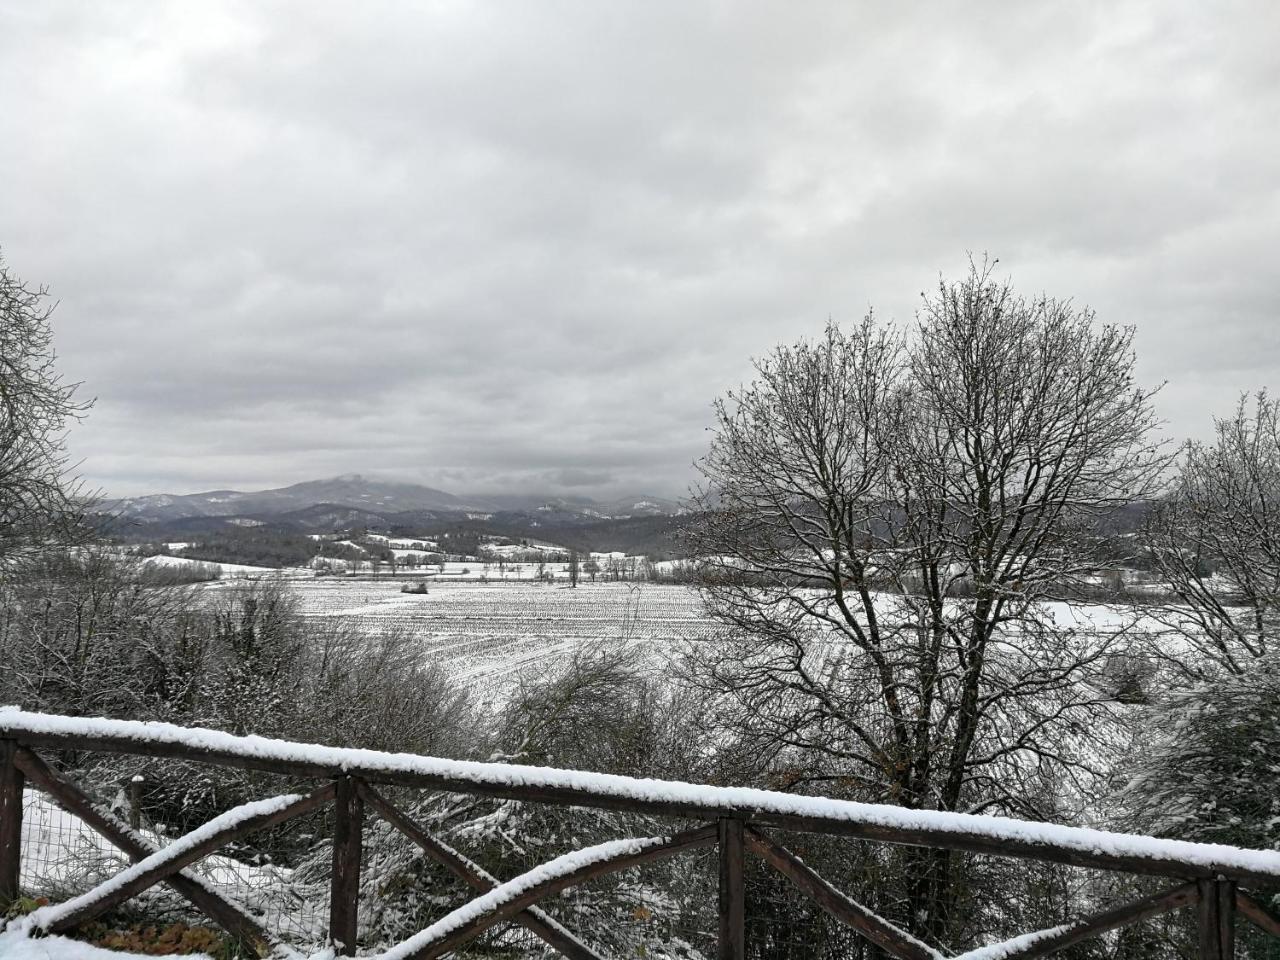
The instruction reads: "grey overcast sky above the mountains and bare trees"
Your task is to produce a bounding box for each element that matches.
[0,0,1280,504]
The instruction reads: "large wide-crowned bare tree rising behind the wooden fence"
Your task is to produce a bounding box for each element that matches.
[686,264,1165,938]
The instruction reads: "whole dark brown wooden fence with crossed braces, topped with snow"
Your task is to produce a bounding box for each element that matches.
[0,707,1280,960]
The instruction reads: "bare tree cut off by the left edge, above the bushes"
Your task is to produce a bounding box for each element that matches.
[0,260,90,557]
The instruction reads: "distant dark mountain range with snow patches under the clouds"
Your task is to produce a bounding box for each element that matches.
[99,474,682,529]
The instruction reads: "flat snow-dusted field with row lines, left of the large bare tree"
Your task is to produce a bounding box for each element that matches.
[262,579,719,694]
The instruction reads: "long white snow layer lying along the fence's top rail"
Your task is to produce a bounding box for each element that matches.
[10,707,1280,877]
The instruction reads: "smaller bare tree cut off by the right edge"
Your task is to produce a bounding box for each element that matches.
[1144,393,1280,677]
